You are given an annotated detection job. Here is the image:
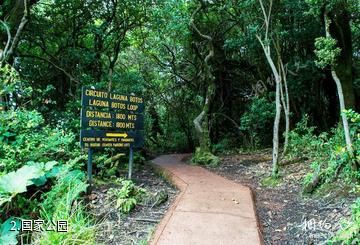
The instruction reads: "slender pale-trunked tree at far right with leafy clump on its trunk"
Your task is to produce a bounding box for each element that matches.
[308,0,356,154]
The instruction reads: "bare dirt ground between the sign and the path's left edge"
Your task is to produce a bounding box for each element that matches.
[89,164,177,245]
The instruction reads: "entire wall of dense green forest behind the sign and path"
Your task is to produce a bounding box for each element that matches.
[0,0,360,244]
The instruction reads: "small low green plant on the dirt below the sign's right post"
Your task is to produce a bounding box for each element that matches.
[108,179,146,214]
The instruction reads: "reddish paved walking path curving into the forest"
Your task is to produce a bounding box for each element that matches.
[151,154,262,245]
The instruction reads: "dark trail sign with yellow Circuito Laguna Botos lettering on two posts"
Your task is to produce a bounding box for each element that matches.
[80,87,144,190]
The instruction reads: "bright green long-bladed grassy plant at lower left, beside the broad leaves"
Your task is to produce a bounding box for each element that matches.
[33,169,96,244]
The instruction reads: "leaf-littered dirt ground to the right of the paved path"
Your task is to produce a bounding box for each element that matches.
[202,151,356,244]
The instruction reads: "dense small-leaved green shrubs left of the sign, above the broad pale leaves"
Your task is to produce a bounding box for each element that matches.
[0,110,76,173]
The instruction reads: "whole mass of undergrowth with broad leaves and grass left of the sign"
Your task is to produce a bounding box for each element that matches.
[0,110,95,245]
